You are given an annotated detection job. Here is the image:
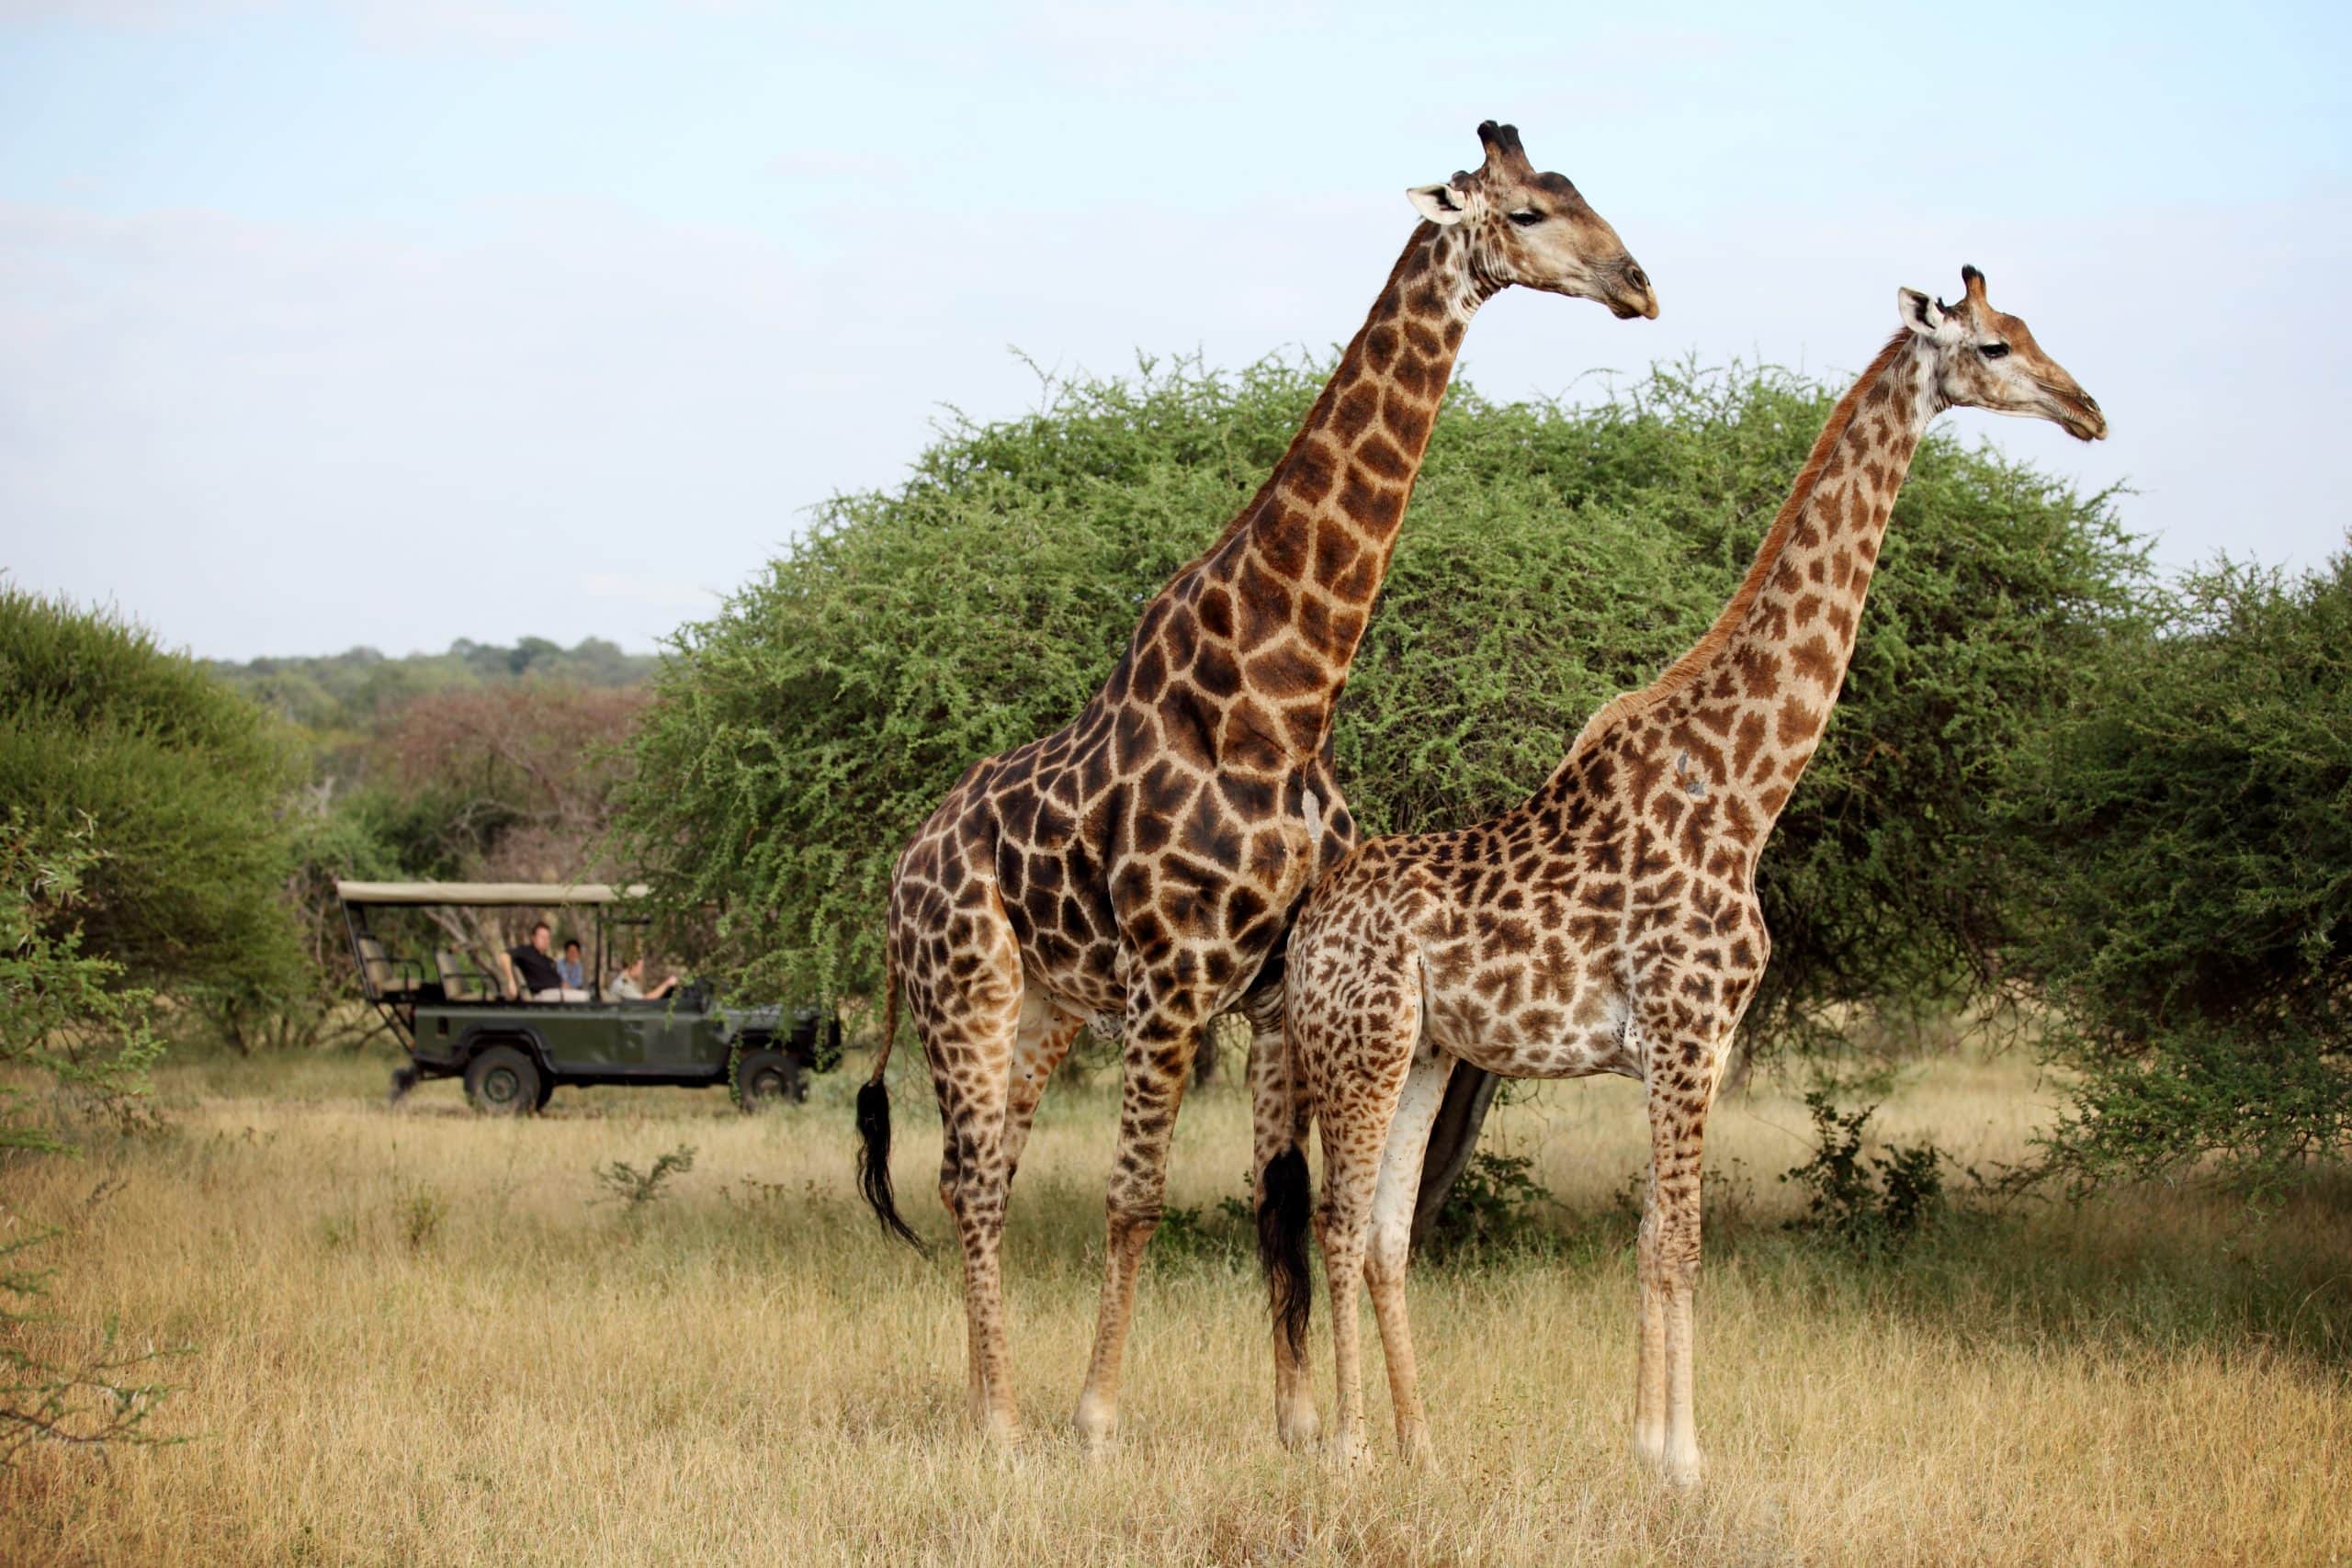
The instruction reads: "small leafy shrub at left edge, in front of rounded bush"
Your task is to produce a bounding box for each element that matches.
[0,808,163,1152]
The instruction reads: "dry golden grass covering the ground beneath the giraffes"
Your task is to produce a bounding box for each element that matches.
[0,1043,2352,1563]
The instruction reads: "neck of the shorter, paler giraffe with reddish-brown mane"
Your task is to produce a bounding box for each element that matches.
[1562,333,1943,844]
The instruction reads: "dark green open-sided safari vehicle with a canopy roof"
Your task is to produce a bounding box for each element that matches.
[334,882,842,1114]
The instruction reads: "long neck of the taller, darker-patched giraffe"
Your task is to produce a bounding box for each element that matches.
[1105,223,1500,761]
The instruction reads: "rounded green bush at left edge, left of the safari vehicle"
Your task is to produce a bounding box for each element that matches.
[0,585,299,992]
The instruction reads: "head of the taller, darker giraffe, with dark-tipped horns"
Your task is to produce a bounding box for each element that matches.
[1407,120,1658,320]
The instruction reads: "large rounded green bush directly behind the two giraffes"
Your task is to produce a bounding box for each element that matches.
[618,362,2138,1039]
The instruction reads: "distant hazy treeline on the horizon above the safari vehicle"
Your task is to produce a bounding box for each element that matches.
[207,637,661,733]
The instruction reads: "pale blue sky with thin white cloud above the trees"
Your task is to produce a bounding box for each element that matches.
[0,0,2352,659]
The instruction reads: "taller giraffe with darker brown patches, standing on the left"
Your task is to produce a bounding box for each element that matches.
[858,120,1658,1443]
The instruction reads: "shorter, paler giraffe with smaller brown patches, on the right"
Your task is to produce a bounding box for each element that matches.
[1256,268,2108,1481]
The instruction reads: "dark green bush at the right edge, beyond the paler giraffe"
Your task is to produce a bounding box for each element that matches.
[2013,555,2352,1187]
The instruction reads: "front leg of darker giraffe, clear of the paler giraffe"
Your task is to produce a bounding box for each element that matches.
[1070,991,1204,1450]
